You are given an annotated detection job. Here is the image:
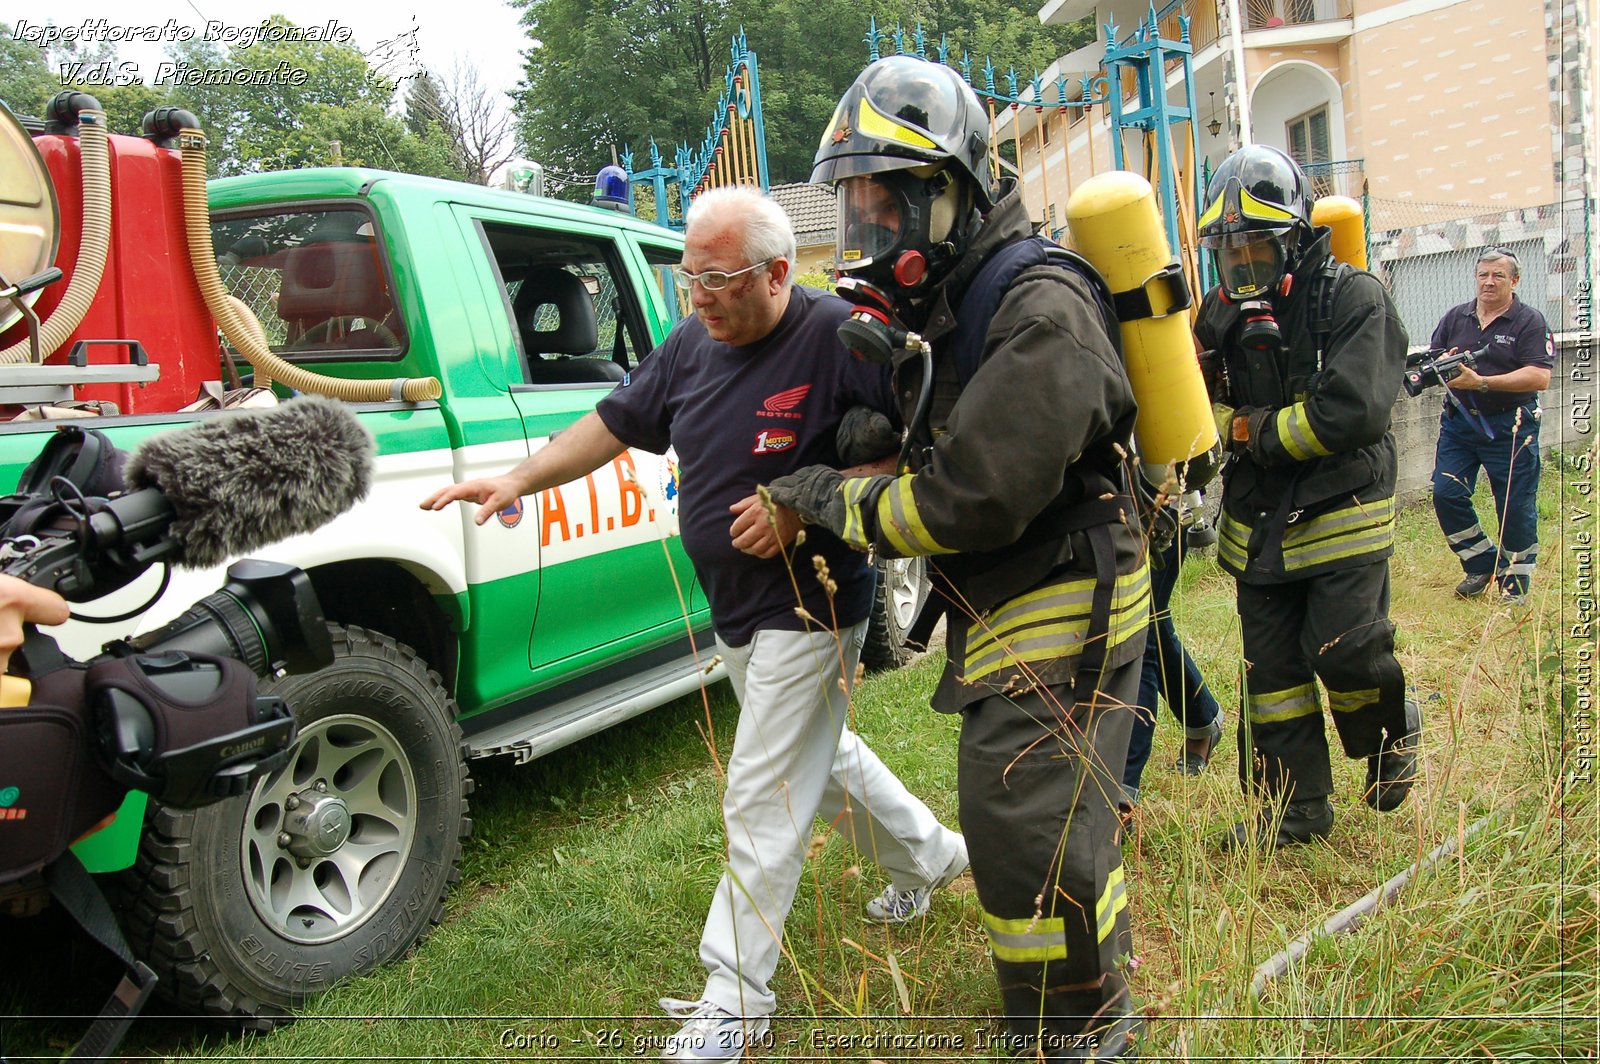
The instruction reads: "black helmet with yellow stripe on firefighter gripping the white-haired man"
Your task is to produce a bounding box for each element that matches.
[811,56,995,290]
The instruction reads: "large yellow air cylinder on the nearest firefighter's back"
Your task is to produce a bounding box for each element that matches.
[1067,170,1218,464]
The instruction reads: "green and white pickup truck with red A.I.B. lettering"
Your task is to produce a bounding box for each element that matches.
[0,168,915,1026]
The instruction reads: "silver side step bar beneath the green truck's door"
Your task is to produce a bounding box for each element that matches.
[466,653,728,765]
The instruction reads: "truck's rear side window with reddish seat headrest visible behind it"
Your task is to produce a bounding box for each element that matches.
[211,208,406,362]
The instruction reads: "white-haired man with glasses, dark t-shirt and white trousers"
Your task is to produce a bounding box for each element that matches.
[422,189,966,1061]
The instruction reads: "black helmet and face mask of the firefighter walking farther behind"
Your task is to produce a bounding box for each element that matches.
[1198,144,1312,301]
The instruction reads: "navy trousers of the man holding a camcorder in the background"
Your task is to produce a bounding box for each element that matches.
[1434,405,1541,592]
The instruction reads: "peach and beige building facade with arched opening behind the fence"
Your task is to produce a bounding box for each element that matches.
[997,0,1600,334]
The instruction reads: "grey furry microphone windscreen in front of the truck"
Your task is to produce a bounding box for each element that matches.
[125,397,374,568]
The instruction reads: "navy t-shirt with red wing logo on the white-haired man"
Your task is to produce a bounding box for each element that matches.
[595,286,896,646]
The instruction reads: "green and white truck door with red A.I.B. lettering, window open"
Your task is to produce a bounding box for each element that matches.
[454,211,693,670]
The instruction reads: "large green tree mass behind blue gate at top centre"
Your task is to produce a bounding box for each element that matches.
[512,0,1091,184]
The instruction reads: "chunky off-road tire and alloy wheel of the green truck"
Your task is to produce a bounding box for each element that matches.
[122,626,472,1030]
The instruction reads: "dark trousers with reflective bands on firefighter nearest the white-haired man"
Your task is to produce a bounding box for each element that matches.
[958,659,1141,1059]
